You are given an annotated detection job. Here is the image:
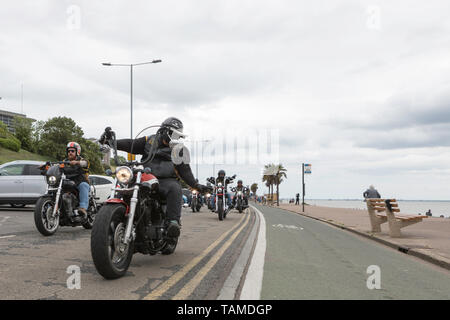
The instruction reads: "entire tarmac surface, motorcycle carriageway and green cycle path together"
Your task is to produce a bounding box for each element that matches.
[0,206,450,300]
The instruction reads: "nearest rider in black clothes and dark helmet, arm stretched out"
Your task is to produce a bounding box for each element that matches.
[100,117,208,238]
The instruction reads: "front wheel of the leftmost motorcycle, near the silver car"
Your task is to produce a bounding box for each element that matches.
[34,197,59,236]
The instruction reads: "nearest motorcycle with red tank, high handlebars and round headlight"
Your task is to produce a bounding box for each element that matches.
[91,127,182,279]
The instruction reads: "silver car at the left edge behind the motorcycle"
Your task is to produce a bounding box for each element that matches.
[0,160,47,208]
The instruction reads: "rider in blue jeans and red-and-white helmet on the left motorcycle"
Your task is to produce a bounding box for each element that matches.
[64,141,90,218]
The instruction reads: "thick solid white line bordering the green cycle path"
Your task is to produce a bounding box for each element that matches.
[239,206,266,300]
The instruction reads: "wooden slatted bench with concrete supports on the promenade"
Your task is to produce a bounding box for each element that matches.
[366,199,427,238]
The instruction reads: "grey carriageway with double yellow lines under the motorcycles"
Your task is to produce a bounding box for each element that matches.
[0,207,255,300]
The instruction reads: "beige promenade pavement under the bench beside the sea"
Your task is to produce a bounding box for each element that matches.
[279,204,450,270]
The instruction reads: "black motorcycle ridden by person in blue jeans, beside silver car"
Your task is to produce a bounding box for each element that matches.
[34,161,99,236]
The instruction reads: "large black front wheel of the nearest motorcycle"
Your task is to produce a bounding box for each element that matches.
[91,204,134,279]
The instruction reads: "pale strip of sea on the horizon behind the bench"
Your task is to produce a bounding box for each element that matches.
[283,199,450,218]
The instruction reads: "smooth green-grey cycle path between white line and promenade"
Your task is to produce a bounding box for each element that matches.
[251,205,450,300]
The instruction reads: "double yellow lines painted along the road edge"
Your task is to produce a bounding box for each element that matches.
[144,213,250,300]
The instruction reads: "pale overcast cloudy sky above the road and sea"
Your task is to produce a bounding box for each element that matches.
[0,0,450,200]
